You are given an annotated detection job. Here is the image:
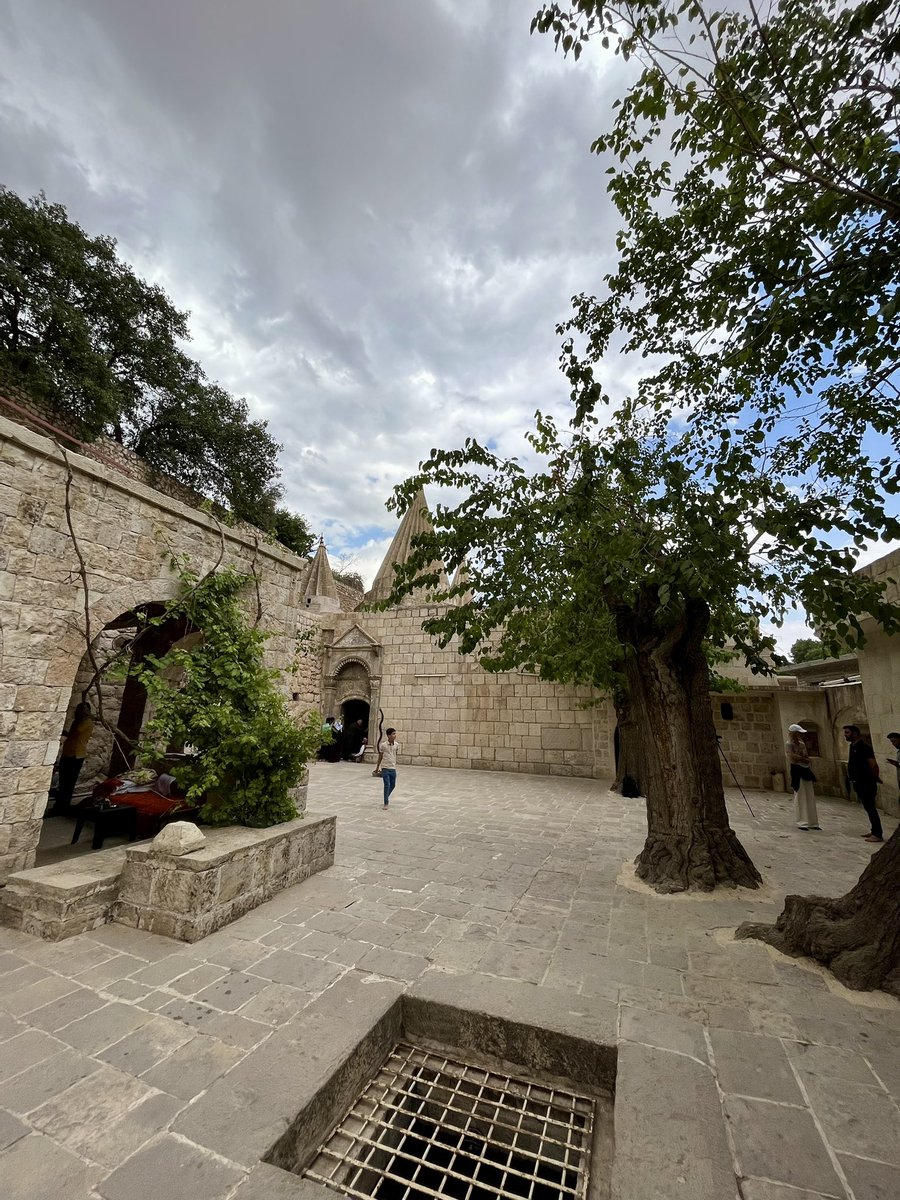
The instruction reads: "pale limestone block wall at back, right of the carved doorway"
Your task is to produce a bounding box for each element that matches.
[328,605,616,779]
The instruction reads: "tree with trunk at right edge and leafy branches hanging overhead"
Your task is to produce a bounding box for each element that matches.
[533,0,900,992]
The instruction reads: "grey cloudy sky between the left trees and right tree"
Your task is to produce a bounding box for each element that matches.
[0,0,622,580]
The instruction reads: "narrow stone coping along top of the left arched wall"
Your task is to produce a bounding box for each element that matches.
[0,416,310,574]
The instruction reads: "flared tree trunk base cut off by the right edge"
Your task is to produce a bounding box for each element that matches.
[736,827,900,996]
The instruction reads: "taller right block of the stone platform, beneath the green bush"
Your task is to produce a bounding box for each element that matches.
[115,816,336,942]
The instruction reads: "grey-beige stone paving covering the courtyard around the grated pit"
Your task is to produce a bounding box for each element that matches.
[0,764,900,1200]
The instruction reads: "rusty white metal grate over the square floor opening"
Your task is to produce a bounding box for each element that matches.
[305,1043,594,1200]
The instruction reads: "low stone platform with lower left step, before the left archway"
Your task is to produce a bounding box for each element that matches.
[0,816,336,942]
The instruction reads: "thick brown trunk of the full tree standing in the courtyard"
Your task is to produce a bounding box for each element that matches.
[617,593,762,892]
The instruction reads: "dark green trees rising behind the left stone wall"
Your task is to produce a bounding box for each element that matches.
[0,187,312,554]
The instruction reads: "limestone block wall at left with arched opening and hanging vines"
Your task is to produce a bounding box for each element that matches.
[0,416,307,880]
